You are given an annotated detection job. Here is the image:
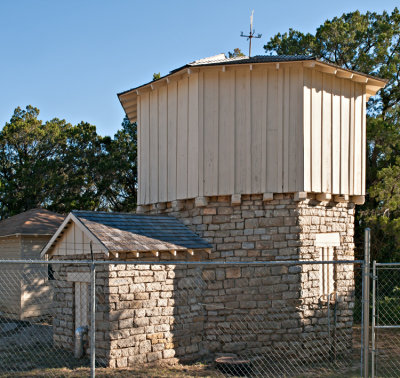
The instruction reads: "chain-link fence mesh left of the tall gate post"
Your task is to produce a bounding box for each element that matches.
[0,261,362,377]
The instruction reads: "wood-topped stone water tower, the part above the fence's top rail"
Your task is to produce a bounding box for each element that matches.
[118,54,386,260]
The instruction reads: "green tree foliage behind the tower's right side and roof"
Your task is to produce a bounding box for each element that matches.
[264,8,400,261]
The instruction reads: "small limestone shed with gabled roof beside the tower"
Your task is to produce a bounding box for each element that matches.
[42,211,211,367]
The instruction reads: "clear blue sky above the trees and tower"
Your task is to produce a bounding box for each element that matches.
[0,0,399,135]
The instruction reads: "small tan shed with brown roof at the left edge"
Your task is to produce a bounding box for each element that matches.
[0,209,64,320]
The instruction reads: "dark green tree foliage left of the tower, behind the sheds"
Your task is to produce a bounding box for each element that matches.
[0,106,137,219]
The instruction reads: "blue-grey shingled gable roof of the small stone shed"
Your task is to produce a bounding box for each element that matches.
[42,211,211,254]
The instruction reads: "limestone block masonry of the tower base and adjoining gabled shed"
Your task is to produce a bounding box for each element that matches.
[50,194,354,367]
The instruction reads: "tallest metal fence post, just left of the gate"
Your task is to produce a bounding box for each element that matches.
[363,228,371,377]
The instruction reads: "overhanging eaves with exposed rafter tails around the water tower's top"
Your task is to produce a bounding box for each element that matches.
[118,58,388,122]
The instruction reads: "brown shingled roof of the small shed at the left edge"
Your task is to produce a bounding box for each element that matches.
[0,209,65,237]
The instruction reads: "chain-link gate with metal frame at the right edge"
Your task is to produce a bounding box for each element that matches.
[371,261,400,377]
